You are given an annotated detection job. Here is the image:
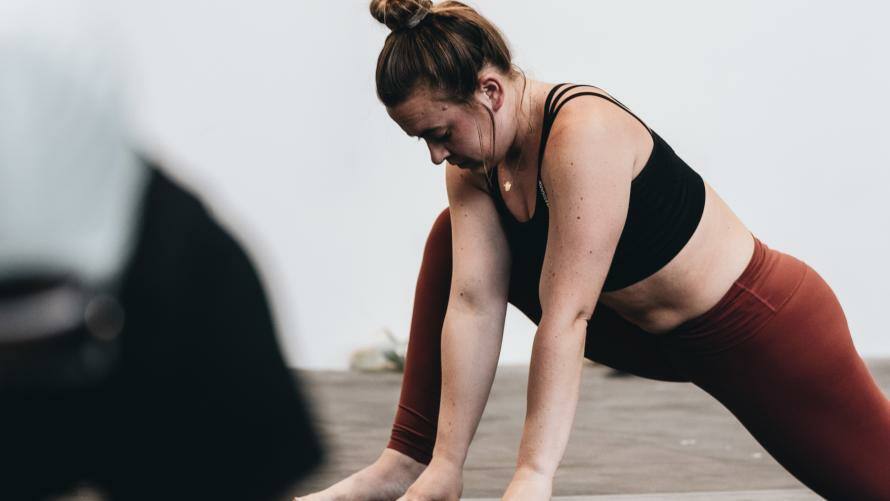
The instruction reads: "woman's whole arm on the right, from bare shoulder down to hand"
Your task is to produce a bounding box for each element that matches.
[505,99,636,499]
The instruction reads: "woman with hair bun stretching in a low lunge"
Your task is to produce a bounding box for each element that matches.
[298,0,890,499]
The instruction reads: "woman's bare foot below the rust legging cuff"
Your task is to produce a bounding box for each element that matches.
[294,448,426,501]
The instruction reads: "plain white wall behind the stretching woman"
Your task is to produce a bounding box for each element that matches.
[108,0,890,368]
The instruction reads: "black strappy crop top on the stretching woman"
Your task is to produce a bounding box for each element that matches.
[488,84,705,292]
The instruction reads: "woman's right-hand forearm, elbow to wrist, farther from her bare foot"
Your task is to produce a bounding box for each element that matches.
[517,319,587,475]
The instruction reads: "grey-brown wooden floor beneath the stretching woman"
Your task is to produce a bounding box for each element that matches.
[286,359,890,501]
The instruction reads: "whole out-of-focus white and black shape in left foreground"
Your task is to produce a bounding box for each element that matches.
[0,1,322,501]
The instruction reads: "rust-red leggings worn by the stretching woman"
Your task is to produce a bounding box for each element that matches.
[388,209,890,500]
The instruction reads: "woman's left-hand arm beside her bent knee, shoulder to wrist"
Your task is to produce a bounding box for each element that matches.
[431,164,510,469]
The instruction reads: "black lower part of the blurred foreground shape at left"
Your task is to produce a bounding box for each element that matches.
[0,162,322,500]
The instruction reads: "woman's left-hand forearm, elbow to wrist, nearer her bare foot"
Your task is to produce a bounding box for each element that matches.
[433,303,506,466]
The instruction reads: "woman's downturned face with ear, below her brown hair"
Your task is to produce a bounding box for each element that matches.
[386,88,505,170]
